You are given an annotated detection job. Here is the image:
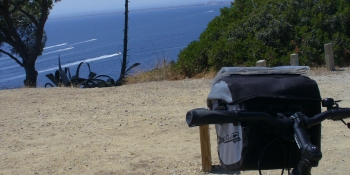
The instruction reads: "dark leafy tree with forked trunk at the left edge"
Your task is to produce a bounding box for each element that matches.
[0,0,60,87]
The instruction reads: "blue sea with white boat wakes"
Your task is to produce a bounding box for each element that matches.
[0,4,229,89]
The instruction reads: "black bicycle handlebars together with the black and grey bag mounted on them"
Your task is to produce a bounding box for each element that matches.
[186,66,350,175]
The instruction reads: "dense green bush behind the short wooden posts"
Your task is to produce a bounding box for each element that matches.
[176,0,350,76]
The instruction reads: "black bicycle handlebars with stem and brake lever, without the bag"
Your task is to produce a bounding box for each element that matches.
[186,98,350,175]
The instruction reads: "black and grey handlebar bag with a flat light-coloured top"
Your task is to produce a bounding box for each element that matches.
[207,66,321,170]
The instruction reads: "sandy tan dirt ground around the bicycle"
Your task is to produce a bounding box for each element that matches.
[0,68,350,175]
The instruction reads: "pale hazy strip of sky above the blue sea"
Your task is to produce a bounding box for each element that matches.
[50,0,210,16]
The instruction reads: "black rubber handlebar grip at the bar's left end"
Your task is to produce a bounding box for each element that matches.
[186,108,237,127]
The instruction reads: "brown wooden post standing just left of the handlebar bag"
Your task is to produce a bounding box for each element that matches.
[199,125,212,172]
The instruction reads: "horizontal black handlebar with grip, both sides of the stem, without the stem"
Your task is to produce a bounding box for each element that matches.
[186,108,350,127]
